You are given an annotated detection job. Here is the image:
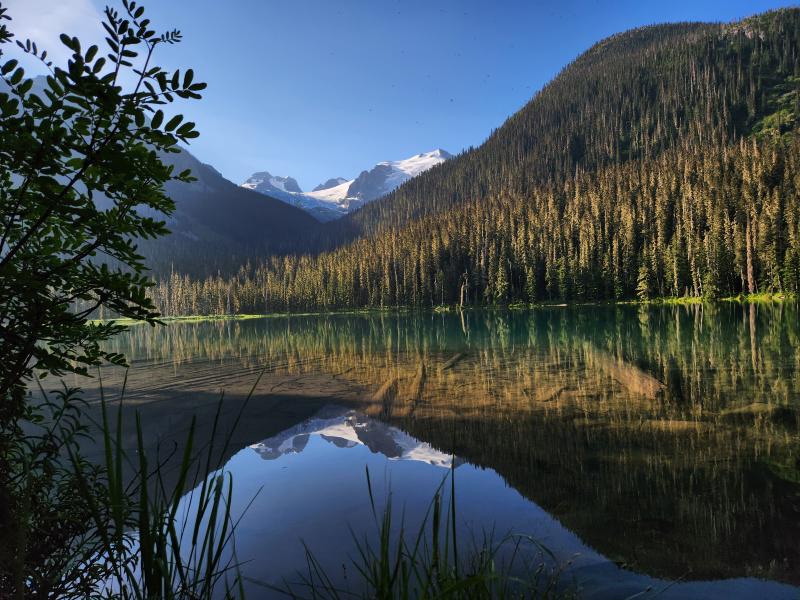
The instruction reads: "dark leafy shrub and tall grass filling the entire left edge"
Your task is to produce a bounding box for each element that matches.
[0,0,244,600]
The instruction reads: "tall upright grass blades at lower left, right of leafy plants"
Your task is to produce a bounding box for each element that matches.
[75,372,258,600]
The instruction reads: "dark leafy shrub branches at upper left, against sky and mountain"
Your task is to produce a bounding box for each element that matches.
[0,0,205,412]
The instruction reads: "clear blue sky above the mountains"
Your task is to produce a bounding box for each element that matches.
[4,0,792,190]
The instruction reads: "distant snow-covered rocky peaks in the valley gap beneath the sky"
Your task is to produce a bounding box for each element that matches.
[242,148,452,221]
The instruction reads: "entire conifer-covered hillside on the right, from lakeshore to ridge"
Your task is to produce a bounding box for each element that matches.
[150,9,800,312]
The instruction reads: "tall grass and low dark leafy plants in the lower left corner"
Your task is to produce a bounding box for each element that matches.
[0,372,258,600]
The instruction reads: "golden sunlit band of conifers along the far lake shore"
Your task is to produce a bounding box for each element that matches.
[119,135,800,315]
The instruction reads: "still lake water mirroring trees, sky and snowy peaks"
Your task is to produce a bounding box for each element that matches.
[95,303,800,598]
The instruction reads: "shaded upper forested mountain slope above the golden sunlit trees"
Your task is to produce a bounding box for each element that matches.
[338,9,798,240]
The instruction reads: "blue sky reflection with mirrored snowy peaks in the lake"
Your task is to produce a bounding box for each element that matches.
[195,408,800,600]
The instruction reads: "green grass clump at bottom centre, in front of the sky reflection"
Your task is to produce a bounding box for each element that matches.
[276,469,574,600]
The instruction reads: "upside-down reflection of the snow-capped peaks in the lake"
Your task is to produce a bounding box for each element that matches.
[250,406,459,468]
